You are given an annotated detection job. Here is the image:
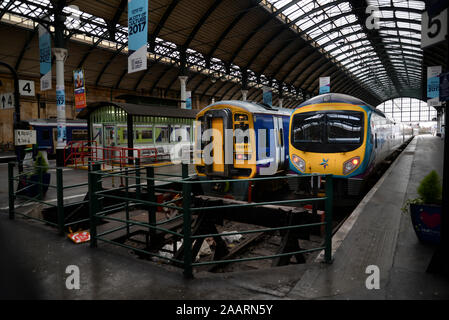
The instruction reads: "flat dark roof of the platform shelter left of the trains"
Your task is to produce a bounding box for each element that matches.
[77,101,198,119]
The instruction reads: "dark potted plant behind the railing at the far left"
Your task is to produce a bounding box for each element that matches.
[18,151,51,197]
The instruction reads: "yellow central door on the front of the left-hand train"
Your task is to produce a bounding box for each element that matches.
[204,109,234,176]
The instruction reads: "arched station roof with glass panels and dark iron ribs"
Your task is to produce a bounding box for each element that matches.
[0,0,447,106]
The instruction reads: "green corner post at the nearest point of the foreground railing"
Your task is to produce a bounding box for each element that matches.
[182,182,193,279]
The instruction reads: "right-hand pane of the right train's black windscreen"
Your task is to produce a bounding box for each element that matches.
[326,112,363,144]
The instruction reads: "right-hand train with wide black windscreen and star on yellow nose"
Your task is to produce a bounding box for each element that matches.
[289,93,412,195]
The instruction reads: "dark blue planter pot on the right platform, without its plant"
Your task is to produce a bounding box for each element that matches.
[410,204,441,244]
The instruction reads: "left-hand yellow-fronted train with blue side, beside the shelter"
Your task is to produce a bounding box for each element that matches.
[194,100,293,179]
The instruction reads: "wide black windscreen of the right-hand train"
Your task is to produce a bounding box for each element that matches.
[291,111,364,153]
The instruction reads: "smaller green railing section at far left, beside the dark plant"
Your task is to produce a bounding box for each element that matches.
[8,162,90,235]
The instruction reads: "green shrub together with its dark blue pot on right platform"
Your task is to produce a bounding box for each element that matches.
[402,170,442,244]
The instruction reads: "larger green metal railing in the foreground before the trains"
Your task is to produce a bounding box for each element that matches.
[89,164,333,278]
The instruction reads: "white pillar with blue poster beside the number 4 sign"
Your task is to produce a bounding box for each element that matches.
[53,48,68,158]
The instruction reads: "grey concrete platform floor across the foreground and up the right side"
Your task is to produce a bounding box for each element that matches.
[0,136,449,300]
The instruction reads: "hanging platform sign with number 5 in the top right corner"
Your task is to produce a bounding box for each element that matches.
[421,9,448,48]
